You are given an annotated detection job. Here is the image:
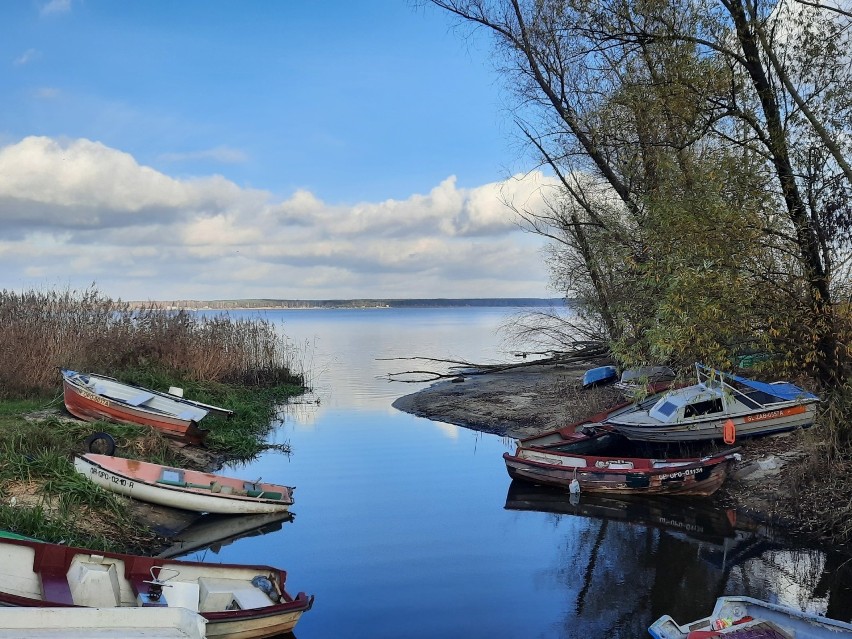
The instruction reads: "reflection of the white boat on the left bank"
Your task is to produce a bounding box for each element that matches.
[157,512,293,558]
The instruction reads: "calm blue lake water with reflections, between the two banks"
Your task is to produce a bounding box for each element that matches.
[185,308,852,639]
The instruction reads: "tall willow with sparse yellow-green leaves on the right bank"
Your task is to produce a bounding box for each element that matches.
[432,0,850,385]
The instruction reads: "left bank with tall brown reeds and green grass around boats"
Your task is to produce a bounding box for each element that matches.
[0,289,305,552]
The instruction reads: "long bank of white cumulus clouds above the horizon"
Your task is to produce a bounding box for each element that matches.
[0,137,552,299]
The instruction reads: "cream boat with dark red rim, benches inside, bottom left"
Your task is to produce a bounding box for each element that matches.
[0,539,314,639]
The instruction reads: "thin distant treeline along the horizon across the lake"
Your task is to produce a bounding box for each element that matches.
[130,297,565,310]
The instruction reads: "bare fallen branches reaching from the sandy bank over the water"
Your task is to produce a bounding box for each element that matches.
[377,342,609,383]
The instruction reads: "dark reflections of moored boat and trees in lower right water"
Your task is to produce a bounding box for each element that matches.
[505,481,852,639]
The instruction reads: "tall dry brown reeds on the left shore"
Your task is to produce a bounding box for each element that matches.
[0,286,304,399]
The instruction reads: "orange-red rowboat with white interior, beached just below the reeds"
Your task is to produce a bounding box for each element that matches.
[62,370,233,444]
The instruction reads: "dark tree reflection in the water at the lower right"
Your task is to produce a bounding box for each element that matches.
[544,510,852,639]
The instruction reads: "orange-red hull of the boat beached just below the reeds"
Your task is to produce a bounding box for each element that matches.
[63,378,207,445]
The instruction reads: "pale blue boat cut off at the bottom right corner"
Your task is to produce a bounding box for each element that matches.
[648,597,852,639]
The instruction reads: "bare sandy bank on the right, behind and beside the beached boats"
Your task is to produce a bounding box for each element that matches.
[393,365,812,532]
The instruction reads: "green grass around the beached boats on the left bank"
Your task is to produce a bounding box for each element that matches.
[0,374,304,552]
